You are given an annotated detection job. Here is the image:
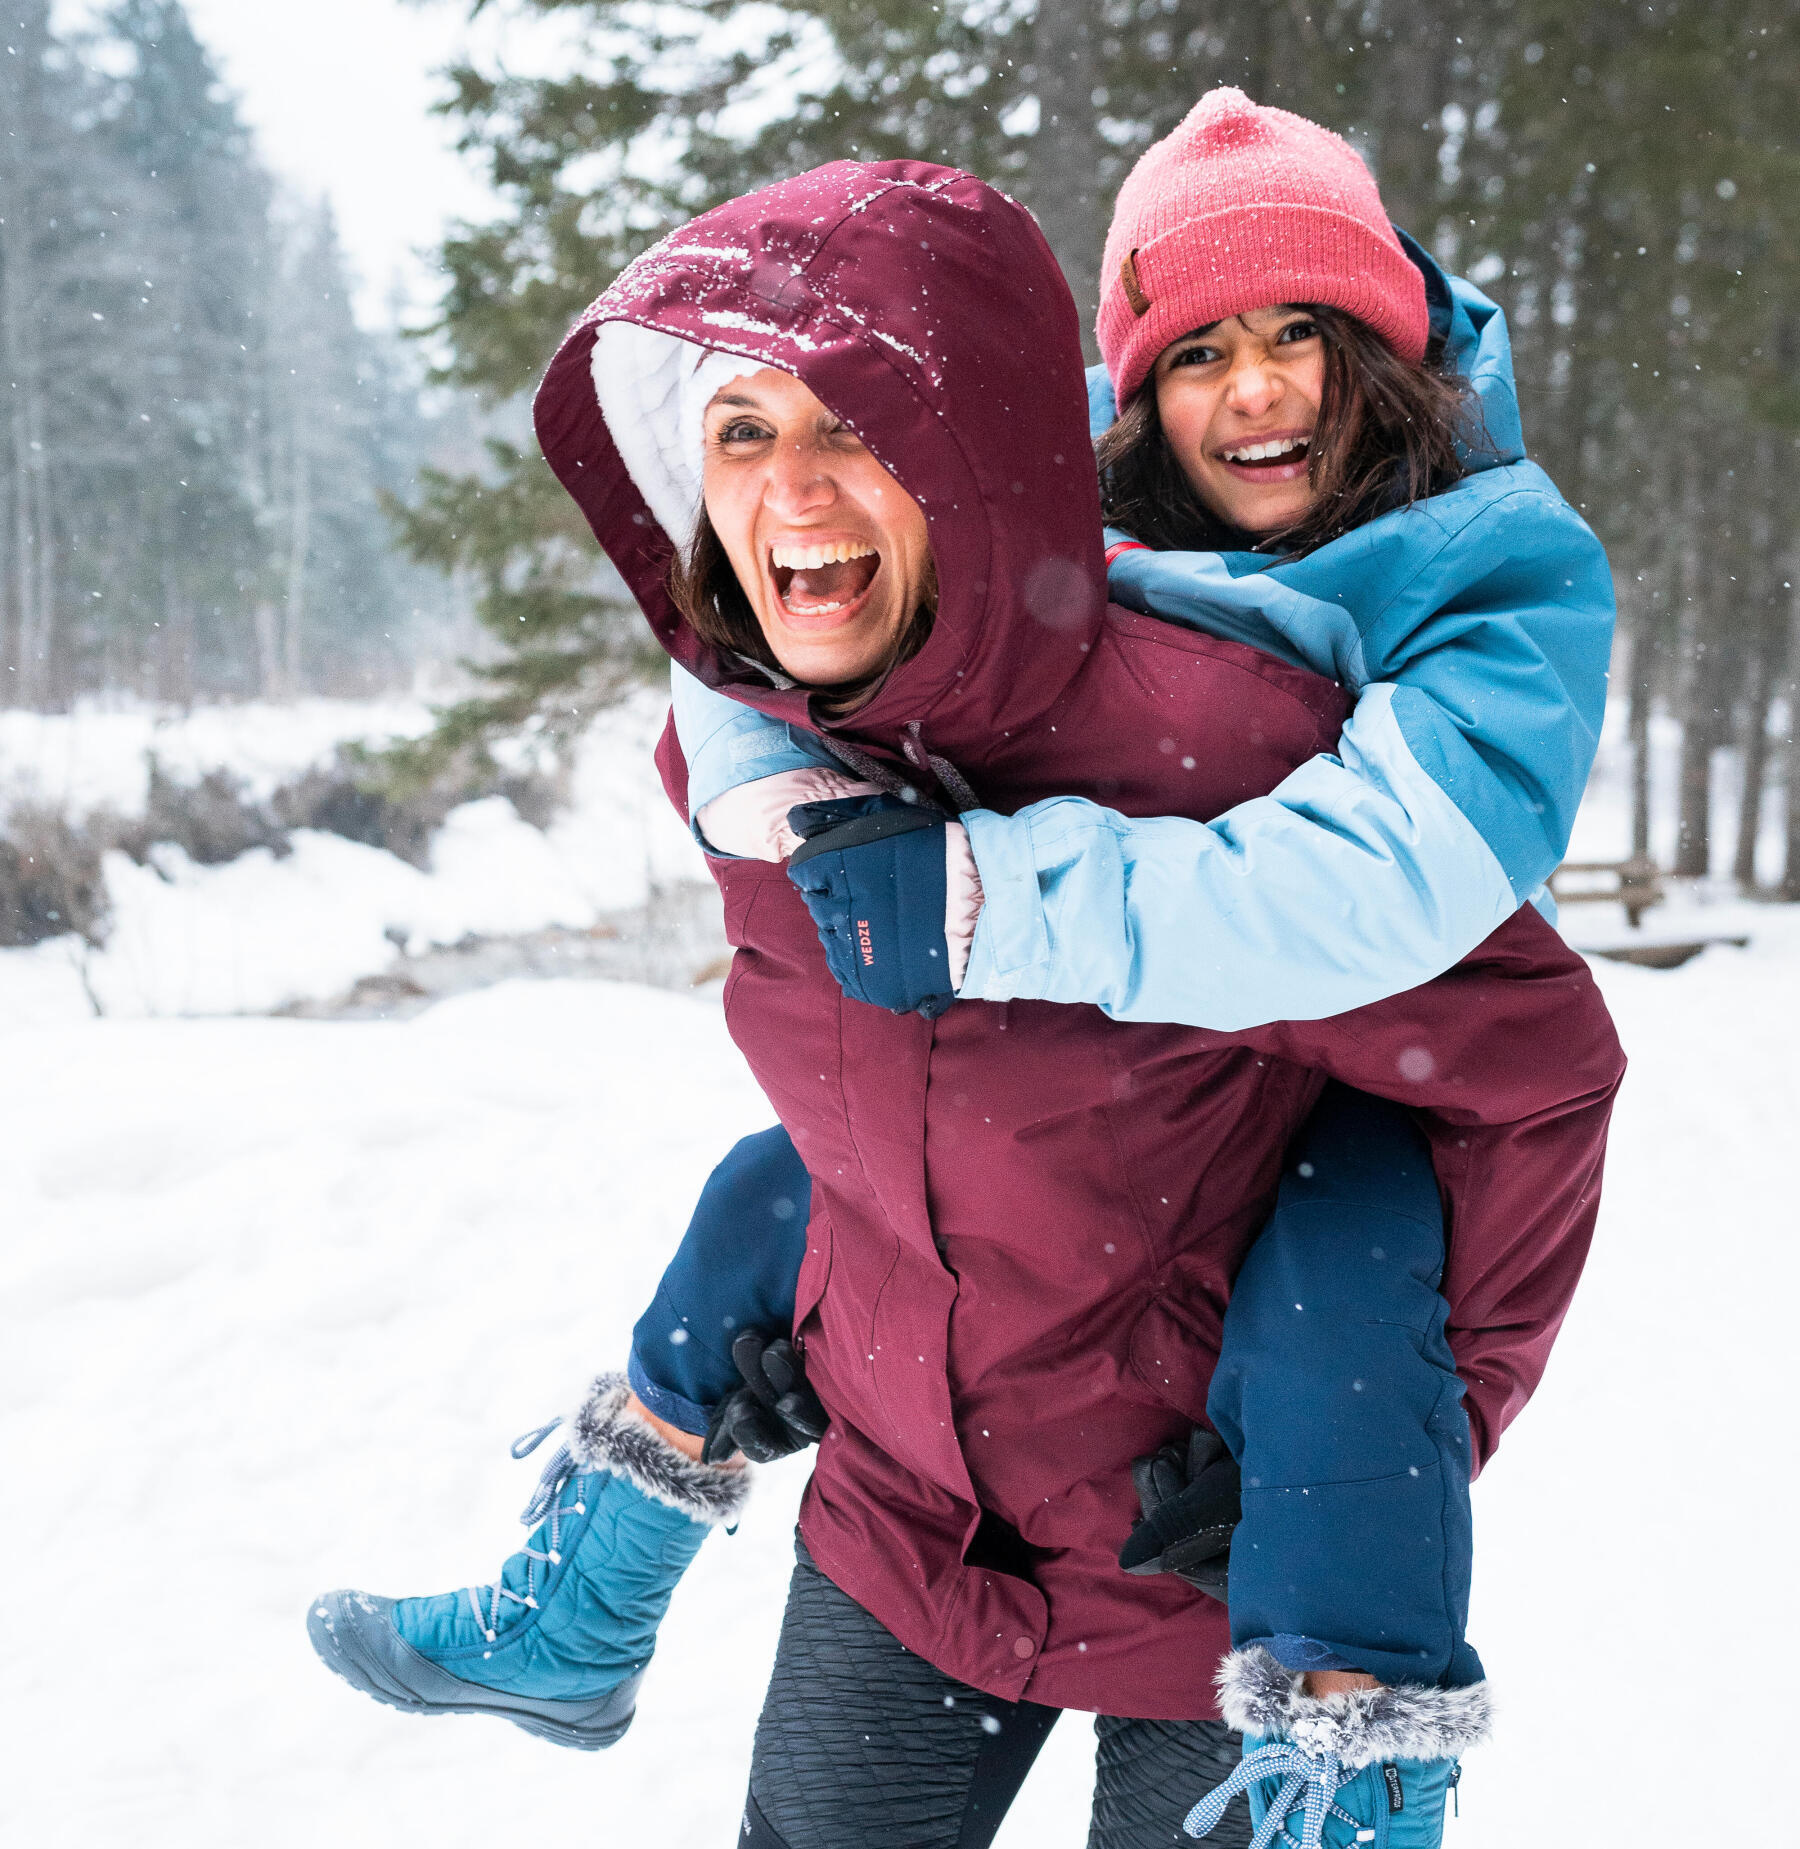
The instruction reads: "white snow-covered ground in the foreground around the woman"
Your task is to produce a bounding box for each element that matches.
[0,924,1800,1849]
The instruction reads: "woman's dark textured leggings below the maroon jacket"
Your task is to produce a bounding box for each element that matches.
[738,1548,1251,1849]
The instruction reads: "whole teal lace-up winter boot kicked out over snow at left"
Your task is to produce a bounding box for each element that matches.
[307,1374,749,1751]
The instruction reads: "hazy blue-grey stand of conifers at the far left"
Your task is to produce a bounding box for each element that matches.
[0,0,473,704]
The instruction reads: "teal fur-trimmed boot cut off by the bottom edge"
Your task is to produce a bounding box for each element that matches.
[1184,1644,1489,1849]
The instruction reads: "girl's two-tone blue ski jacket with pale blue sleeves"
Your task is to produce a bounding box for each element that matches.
[675,239,1613,1030]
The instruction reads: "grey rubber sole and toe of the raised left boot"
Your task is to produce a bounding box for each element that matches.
[307,1592,644,1753]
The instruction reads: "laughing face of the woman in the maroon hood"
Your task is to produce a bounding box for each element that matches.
[703,368,932,688]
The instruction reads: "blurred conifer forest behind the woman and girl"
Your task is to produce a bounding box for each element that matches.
[0,0,1800,899]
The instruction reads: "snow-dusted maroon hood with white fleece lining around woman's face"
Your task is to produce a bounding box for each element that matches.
[536,161,1106,756]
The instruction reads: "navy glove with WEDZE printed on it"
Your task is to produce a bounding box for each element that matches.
[788,795,956,1021]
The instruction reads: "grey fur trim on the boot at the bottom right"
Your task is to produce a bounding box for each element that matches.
[1217,1644,1493,1771]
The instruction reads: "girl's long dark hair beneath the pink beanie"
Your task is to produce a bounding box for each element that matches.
[1095,307,1480,557]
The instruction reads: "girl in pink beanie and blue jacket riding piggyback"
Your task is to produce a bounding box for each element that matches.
[314,91,1613,1842]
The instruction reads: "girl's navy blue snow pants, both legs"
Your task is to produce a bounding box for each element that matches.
[629,1085,1482,1688]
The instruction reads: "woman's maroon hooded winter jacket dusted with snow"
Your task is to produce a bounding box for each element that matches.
[538,163,1622,1718]
